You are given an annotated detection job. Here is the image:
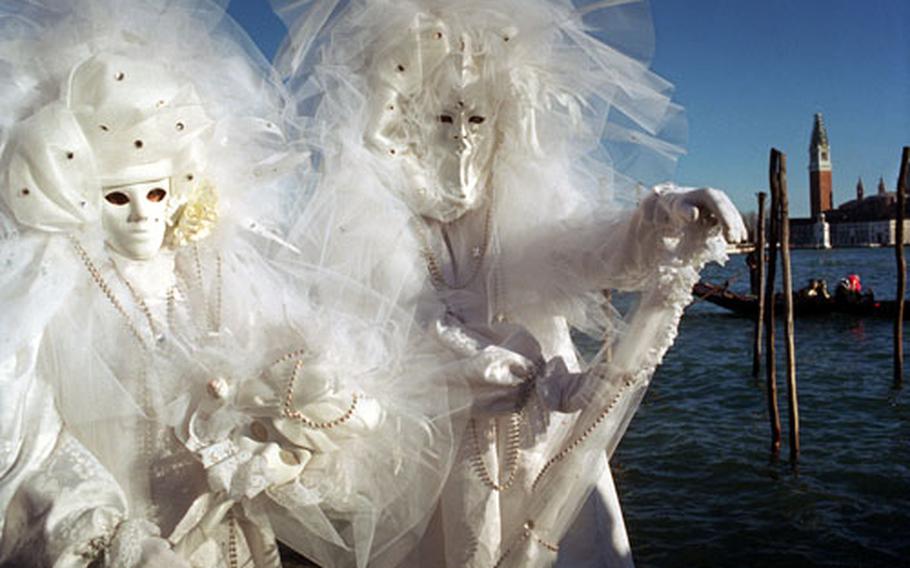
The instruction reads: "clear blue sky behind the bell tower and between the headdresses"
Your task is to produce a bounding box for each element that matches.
[228,0,910,216]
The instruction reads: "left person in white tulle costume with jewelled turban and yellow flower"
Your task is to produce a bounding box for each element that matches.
[0,0,455,568]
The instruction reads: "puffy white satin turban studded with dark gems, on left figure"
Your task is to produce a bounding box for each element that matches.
[7,53,212,231]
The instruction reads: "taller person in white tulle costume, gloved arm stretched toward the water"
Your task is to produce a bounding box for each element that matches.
[273,0,745,567]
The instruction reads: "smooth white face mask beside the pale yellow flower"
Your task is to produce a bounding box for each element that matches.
[101,178,171,260]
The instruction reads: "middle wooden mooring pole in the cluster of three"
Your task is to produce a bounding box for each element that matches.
[765,150,780,457]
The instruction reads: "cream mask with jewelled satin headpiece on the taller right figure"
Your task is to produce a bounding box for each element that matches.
[367,30,501,222]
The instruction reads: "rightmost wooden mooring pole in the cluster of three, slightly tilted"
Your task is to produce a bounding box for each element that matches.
[777,151,799,464]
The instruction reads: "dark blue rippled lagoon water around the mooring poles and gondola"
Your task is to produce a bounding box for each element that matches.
[613,249,910,568]
